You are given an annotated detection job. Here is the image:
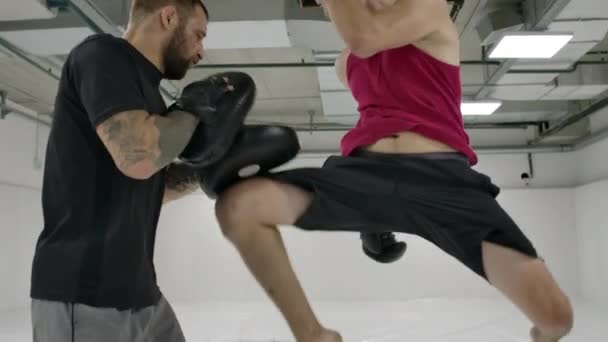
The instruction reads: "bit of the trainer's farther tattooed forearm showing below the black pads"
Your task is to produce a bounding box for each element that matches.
[163,164,199,204]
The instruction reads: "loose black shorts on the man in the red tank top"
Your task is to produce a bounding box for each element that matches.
[272,151,537,279]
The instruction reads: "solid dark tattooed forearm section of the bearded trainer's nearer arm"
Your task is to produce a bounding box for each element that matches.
[154,111,198,169]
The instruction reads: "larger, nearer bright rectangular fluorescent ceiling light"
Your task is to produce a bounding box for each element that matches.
[490,32,574,58]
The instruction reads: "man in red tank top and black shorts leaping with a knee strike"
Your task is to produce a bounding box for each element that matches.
[216,0,573,342]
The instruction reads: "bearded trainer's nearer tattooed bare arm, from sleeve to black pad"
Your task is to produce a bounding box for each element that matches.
[97,110,199,179]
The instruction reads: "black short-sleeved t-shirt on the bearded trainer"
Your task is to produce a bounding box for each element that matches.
[31,34,167,309]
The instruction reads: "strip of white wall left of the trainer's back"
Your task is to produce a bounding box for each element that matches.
[0,115,49,309]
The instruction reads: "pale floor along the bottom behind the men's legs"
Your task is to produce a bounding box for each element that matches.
[0,299,608,342]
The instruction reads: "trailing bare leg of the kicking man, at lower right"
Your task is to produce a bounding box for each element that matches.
[482,242,573,342]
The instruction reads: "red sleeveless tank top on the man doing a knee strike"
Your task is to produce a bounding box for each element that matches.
[341,45,477,165]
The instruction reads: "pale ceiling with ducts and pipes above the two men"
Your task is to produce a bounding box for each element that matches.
[0,0,608,151]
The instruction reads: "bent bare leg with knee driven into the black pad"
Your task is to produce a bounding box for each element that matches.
[216,179,342,342]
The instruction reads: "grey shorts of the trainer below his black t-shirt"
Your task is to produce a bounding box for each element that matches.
[31,297,186,342]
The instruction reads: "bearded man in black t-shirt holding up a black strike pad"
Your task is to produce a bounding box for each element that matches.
[31,0,255,342]
